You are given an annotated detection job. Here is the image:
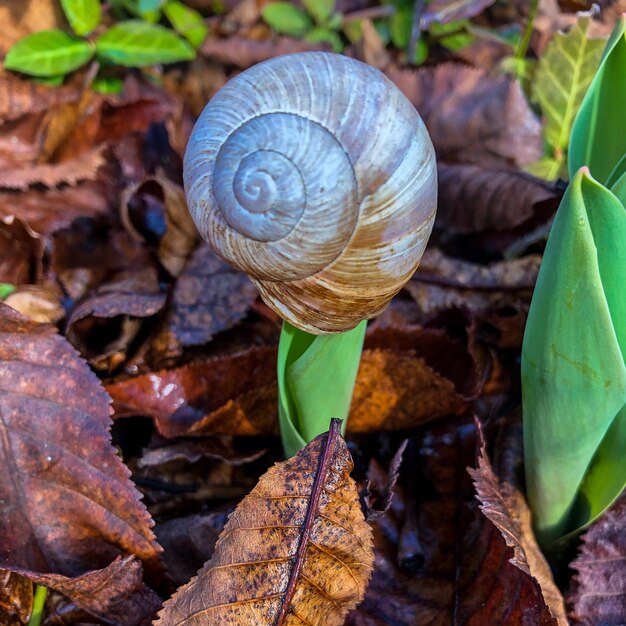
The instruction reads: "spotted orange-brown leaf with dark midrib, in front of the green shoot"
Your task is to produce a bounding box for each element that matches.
[157,420,373,626]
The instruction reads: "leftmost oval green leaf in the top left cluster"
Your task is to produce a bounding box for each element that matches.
[4,30,94,76]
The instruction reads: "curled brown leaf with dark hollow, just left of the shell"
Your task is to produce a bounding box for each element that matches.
[120,176,198,276]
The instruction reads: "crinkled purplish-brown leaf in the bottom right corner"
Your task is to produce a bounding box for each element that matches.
[567,493,626,626]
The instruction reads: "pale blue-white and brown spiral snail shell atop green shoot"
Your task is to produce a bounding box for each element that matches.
[184,52,437,334]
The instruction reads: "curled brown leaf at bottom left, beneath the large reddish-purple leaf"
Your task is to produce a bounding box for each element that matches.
[6,556,161,626]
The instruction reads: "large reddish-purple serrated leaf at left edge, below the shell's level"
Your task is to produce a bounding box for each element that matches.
[0,304,161,580]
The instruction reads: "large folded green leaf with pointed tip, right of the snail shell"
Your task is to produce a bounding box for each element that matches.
[522,168,626,547]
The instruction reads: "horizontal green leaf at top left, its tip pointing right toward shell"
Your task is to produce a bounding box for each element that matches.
[96,20,196,67]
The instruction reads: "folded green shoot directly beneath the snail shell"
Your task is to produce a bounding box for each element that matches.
[278,321,367,457]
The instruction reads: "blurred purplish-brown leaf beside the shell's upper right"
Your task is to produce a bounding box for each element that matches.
[387,63,543,169]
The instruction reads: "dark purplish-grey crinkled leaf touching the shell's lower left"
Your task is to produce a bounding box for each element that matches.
[169,244,257,346]
